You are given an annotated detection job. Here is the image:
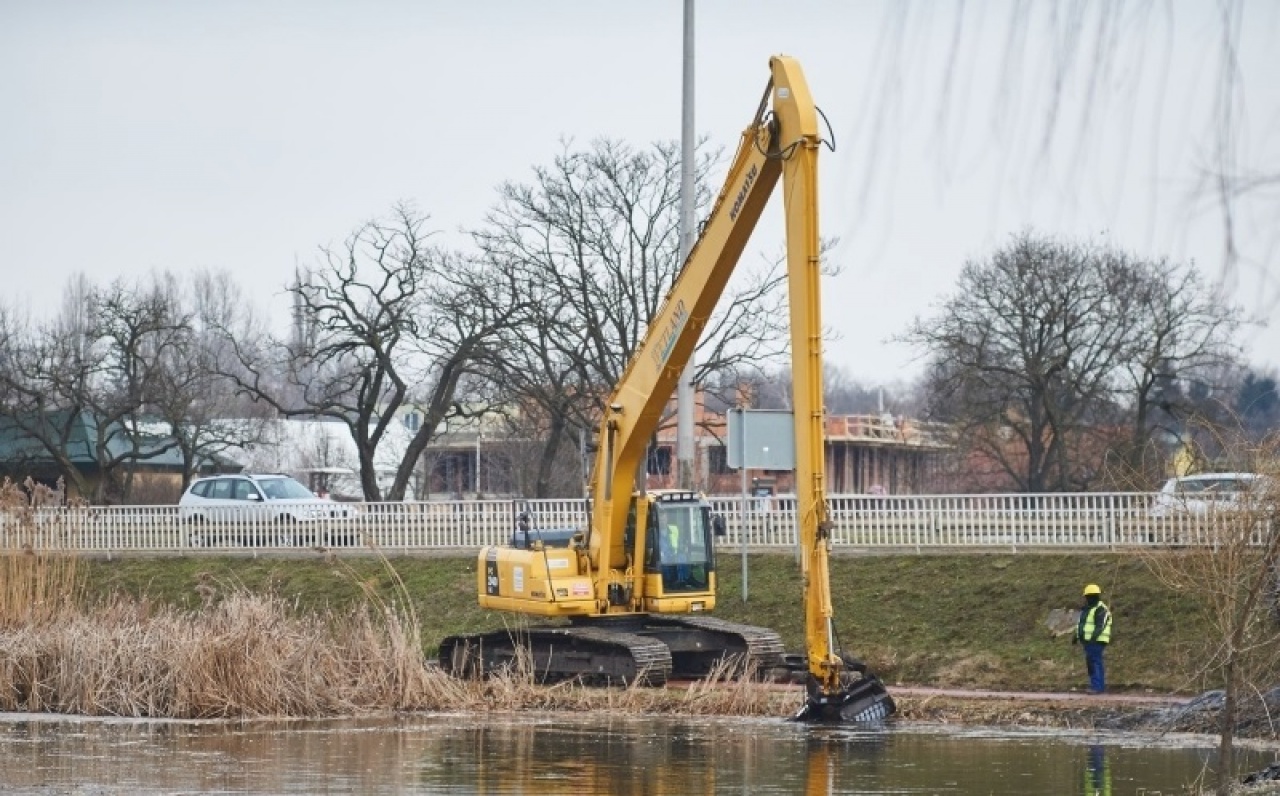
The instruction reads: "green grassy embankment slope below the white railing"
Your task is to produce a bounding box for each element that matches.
[81,553,1204,692]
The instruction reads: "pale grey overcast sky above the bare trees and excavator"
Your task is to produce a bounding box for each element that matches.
[0,0,1280,383]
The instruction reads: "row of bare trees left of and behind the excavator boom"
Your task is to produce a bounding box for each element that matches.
[0,141,808,500]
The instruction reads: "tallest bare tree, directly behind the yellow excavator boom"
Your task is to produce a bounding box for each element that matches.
[474,141,814,494]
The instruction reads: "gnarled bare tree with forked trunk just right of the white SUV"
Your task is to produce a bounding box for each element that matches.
[224,205,518,500]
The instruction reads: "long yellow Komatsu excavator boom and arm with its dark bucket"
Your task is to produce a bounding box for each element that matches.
[588,56,893,719]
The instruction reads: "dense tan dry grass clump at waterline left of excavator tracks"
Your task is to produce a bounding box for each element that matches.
[0,593,449,718]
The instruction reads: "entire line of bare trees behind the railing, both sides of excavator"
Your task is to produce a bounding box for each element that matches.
[0,141,1280,502]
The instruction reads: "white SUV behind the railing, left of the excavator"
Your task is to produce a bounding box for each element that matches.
[178,474,356,546]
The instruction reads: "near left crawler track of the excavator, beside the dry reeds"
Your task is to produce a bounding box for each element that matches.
[439,625,672,686]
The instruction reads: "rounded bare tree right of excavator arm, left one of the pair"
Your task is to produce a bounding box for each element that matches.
[905,234,1124,491]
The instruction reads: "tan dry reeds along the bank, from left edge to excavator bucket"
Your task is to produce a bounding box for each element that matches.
[0,481,797,718]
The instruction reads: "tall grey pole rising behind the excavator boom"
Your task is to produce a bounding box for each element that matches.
[676,0,696,489]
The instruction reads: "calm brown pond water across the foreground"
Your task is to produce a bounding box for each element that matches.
[0,714,1266,796]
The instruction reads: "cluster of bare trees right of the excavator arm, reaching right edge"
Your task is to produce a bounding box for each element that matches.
[902,233,1280,491]
